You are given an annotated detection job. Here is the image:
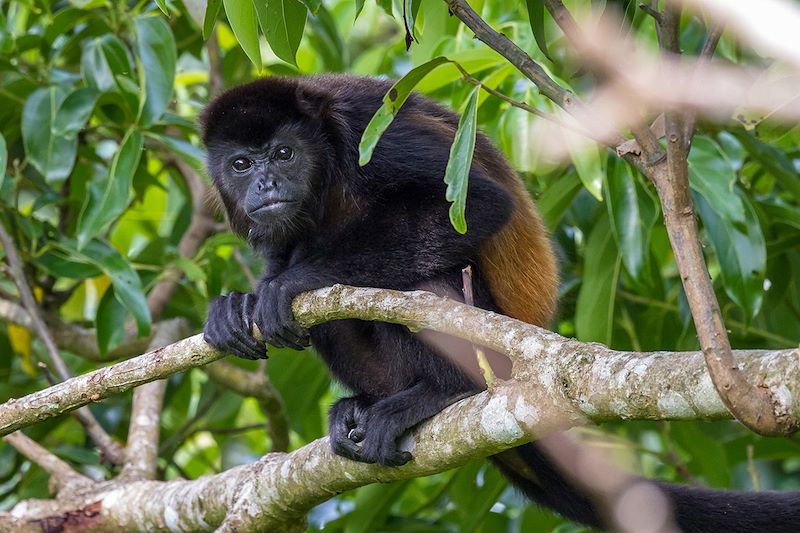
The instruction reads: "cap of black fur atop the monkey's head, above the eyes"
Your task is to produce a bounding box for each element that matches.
[200,78,307,146]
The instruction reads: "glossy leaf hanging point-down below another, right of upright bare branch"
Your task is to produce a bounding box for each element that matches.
[694,190,767,321]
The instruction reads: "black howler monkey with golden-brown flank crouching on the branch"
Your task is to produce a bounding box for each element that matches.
[201,75,800,533]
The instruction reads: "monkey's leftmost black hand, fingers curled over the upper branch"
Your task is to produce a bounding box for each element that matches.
[203,292,267,359]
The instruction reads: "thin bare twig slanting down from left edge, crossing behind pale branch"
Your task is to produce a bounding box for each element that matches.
[0,224,124,464]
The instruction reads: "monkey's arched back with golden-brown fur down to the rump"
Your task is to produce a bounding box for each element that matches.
[300,74,558,327]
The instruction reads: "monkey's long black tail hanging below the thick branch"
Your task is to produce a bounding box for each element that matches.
[492,444,800,533]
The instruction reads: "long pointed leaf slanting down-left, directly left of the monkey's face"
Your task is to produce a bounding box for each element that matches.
[77,129,143,248]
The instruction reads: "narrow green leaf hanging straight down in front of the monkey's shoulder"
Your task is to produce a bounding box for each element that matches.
[444,87,480,234]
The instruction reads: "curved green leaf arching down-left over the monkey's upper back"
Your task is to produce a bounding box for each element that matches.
[358,57,450,167]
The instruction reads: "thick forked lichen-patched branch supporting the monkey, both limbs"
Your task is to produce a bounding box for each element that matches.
[0,286,800,531]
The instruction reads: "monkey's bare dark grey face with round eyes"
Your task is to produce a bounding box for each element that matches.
[208,124,318,235]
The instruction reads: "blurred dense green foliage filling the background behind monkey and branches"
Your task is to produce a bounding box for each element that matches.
[0,0,800,532]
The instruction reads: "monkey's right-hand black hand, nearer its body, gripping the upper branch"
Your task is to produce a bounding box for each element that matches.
[253,271,310,350]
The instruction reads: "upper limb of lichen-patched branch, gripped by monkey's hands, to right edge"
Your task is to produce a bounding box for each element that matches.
[0,285,800,435]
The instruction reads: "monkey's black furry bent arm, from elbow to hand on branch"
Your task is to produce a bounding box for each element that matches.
[253,172,513,339]
